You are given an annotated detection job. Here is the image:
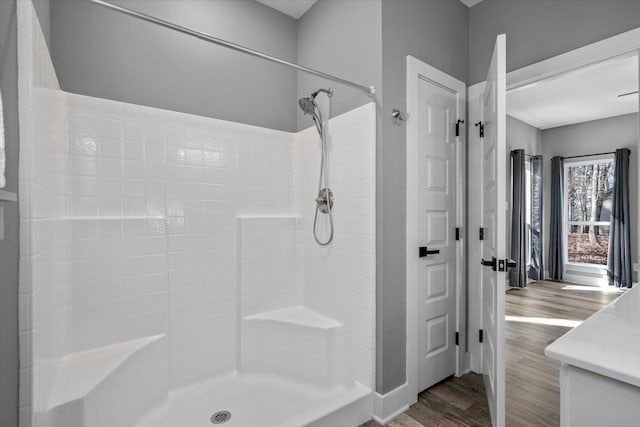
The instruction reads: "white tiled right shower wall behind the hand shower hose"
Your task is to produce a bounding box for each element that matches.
[294,103,376,388]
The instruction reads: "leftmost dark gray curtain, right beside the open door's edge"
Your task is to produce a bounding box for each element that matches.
[509,150,527,288]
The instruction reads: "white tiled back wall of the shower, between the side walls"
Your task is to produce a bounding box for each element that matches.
[69,95,293,387]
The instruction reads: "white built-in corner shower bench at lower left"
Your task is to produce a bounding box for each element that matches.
[47,334,167,427]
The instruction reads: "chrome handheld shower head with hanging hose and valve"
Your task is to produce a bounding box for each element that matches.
[298,89,333,246]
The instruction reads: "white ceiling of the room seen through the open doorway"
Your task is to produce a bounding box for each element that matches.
[507,54,638,129]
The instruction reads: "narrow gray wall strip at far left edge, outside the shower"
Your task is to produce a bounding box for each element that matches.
[0,0,19,427]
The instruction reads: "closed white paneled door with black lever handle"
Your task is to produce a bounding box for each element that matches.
[416,64,464,391]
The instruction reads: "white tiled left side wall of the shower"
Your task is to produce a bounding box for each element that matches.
[17,2,71,425]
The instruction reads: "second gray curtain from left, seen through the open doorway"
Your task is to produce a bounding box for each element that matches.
[527,156,544,280]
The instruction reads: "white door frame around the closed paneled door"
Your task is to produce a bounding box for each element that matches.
[406,55,469,405]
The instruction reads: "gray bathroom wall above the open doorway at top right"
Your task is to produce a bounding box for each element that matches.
[469,0,640,84]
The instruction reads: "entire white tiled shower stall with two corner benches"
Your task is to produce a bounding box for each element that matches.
[18,0,376,427]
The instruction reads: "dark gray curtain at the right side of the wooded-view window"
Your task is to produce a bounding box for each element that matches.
[607,148,632,288]
